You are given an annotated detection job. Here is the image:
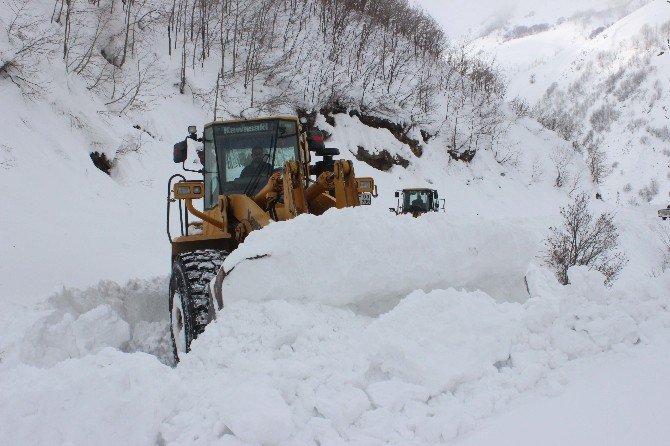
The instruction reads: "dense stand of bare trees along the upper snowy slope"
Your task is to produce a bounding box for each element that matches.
[40,0,510,138]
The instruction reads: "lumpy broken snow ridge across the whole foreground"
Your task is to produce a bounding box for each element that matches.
[0,267,670,445]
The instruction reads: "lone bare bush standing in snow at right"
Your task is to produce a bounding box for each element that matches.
[544,194,628,285]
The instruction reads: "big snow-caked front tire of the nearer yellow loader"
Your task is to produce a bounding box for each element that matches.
[169,249,228,364]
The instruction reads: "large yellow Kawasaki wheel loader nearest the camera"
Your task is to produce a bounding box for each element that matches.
[167,116,377,362]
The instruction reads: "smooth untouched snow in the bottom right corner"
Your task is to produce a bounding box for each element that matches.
[455,344,670,446]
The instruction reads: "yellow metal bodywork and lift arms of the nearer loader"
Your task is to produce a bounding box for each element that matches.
[172,116,375,256]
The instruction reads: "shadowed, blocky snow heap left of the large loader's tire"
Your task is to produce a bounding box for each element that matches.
[3,277,172,367]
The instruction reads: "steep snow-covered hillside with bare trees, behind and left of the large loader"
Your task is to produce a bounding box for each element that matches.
[0,0,507,302]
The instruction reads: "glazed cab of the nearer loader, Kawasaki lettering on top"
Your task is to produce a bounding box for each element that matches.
[203,118,302,209]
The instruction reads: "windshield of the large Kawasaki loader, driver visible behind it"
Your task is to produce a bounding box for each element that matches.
[213,119,298,196]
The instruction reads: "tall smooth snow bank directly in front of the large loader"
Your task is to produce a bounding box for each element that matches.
[224,208,539,312]
